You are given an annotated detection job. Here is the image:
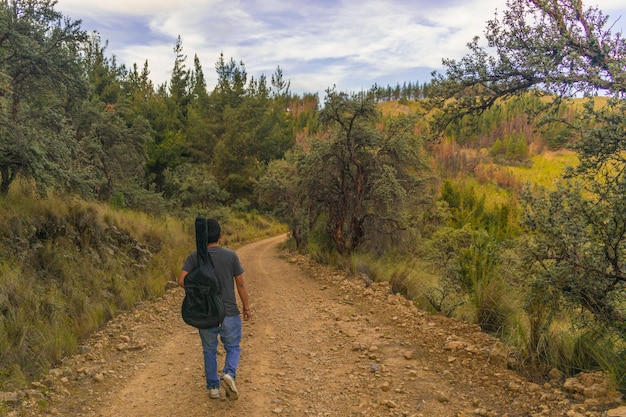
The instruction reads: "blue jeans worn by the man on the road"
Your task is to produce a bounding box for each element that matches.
[198,315,241,389]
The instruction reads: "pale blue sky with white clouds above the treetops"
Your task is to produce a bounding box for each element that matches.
[56,0,626,97]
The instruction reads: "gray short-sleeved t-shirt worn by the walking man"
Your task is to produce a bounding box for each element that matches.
[183,246,243,316]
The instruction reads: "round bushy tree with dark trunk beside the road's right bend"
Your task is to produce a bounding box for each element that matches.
[298,90,430,254]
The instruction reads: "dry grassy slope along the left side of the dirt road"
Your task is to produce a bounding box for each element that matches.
[0,190,285,391]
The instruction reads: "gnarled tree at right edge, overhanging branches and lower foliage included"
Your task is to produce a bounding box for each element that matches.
[429,0,626,342]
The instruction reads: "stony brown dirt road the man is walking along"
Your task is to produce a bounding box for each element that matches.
[14,236,620,417]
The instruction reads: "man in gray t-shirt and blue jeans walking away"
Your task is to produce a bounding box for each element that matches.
[177,219,252,400]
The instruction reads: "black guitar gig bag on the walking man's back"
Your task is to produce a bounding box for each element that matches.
[181,216,226,329]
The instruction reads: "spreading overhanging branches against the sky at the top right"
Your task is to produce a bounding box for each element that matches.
[428,0,626,130]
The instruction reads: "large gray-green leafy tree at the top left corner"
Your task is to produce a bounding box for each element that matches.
[0,0,87,194]
